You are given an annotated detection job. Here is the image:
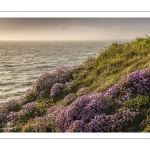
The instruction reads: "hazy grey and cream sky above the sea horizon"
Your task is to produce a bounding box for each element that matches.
[0,18,150,40]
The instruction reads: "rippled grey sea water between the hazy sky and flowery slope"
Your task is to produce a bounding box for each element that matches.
[0,41,129,103]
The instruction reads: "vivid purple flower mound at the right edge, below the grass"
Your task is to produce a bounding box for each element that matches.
[104,69,150,101]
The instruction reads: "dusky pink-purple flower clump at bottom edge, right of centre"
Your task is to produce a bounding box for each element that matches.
[84,109,142,132]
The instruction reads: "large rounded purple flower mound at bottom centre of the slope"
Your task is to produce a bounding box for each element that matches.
[56,95,106,132]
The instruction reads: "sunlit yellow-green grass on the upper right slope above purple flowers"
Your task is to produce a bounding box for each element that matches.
[70,38,150,92]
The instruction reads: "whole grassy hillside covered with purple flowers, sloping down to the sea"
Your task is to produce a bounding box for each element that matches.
[0,37,150,132]
